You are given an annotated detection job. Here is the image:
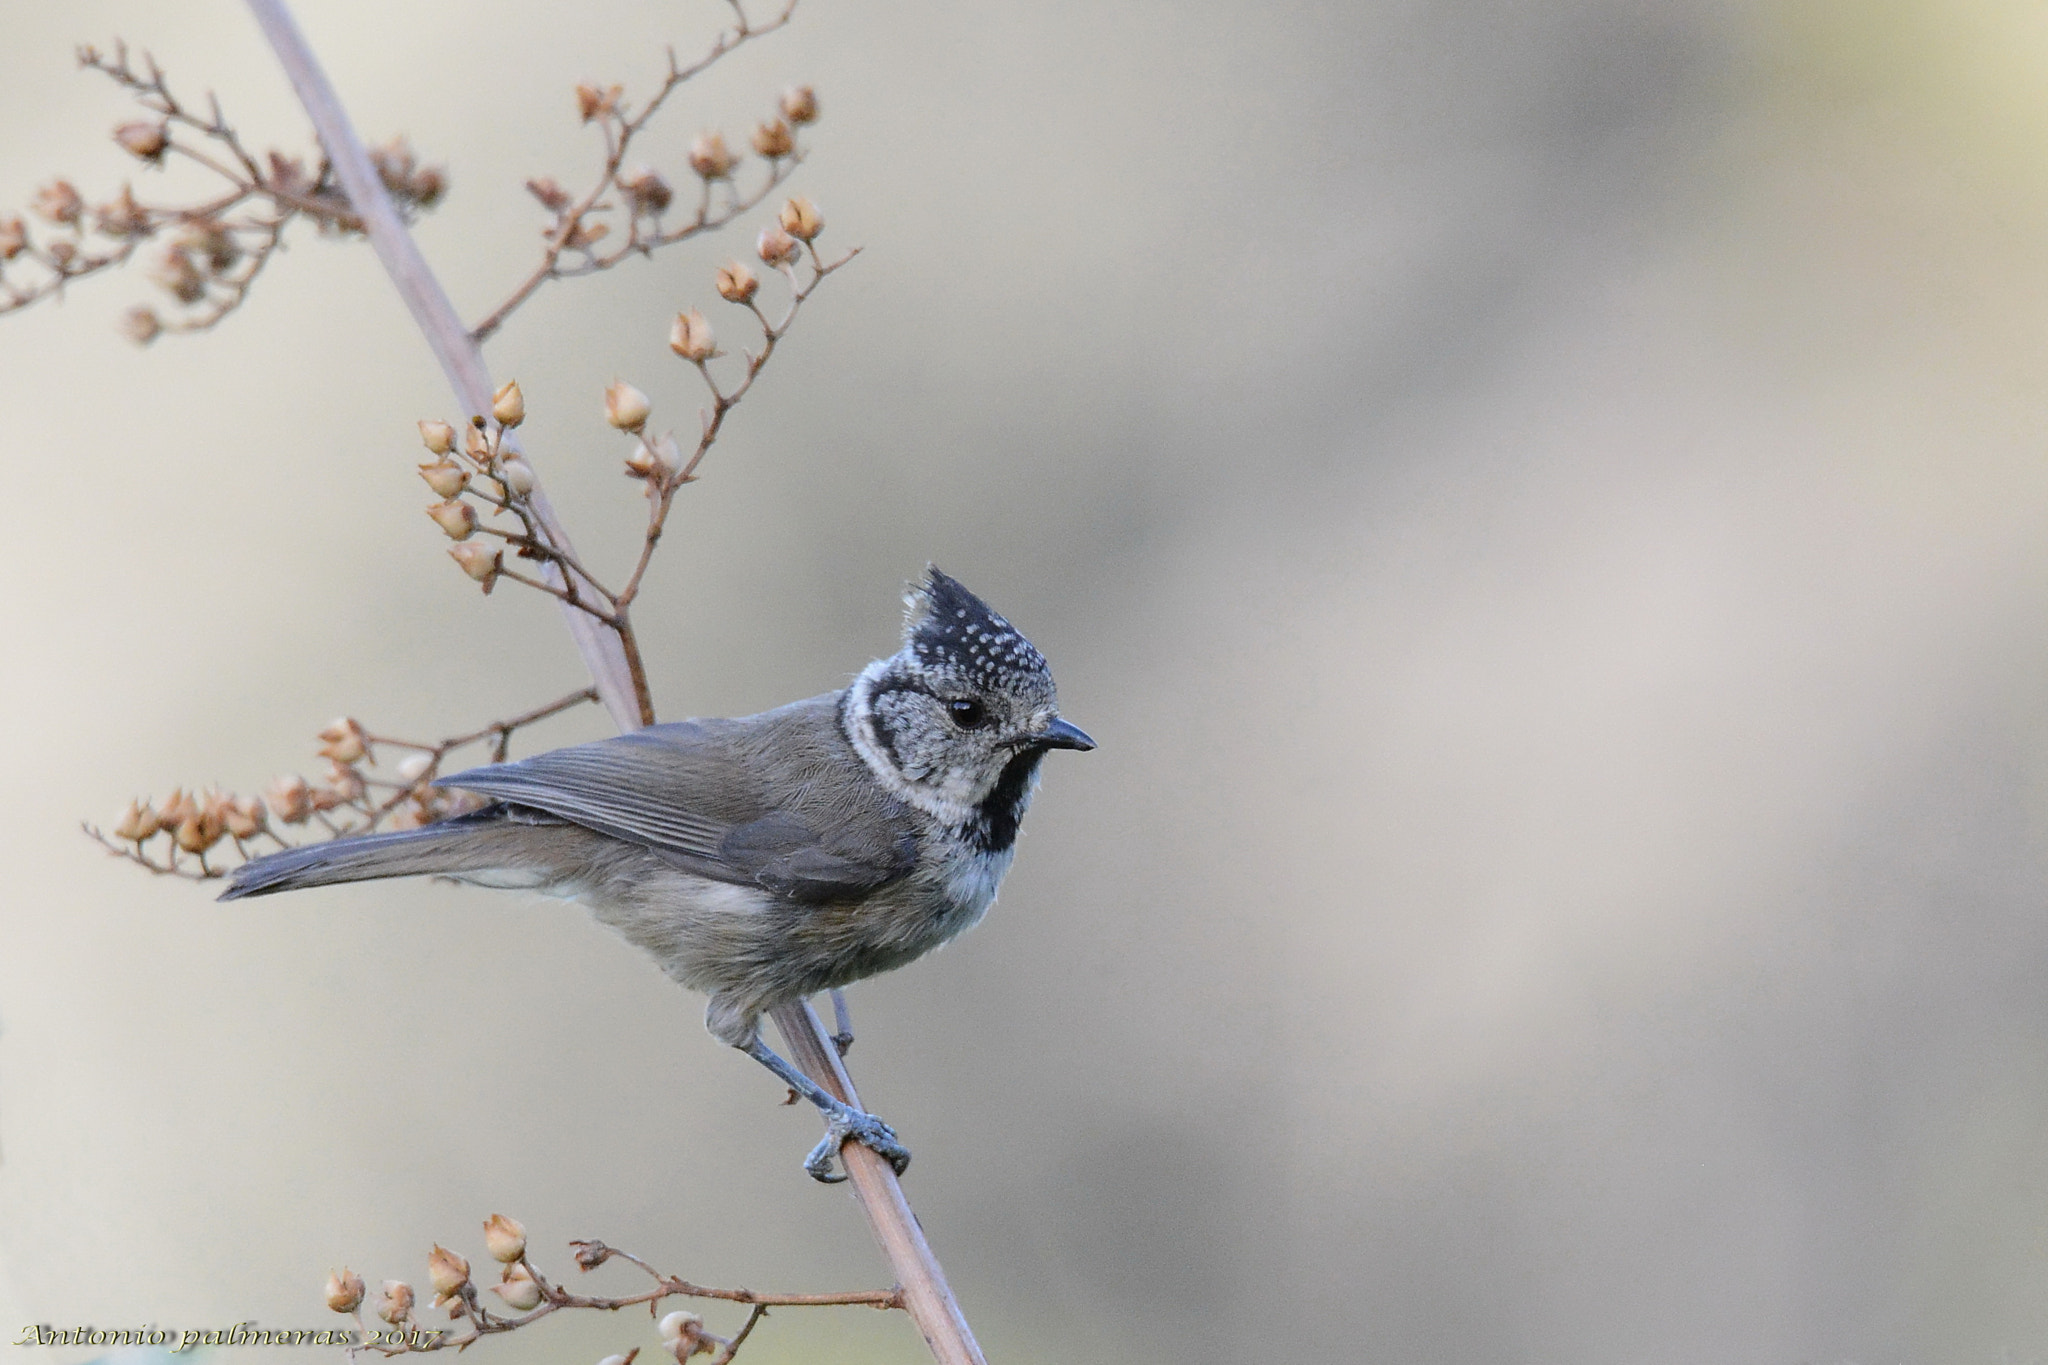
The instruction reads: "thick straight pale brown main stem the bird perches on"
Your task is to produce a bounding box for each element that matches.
[248,0,985,1365]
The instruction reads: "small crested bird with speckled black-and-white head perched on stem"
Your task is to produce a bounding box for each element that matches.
[221,565,1096,1183]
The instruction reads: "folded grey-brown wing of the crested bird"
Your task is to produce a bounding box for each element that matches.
[436,720,915,902]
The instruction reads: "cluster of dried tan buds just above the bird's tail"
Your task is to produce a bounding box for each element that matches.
[88,716,479,878]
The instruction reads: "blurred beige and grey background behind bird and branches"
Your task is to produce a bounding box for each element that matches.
[0,0,2048,1365]
